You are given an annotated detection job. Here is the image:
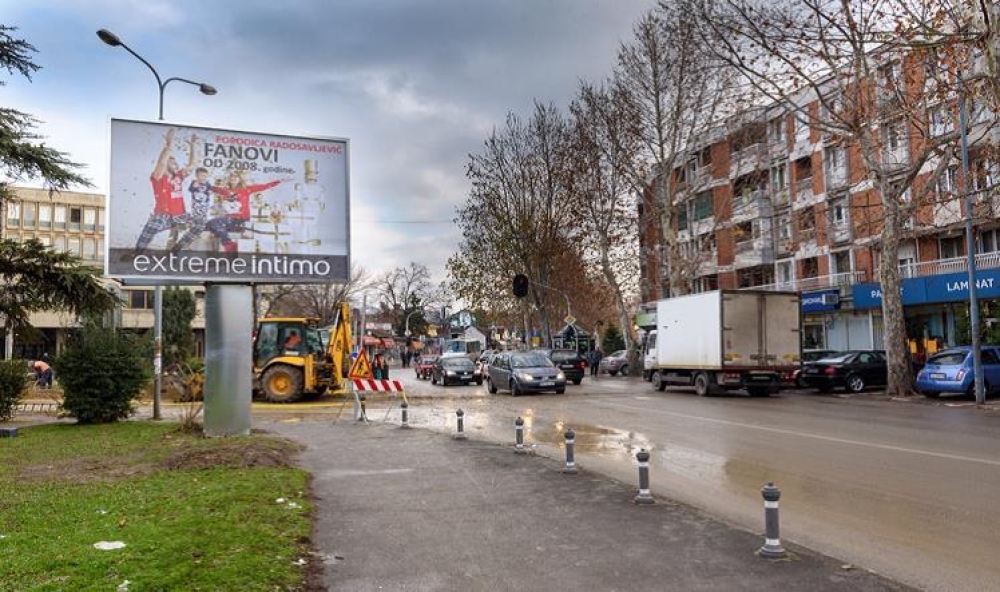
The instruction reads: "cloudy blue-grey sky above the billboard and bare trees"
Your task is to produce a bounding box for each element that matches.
[0,0,654,281]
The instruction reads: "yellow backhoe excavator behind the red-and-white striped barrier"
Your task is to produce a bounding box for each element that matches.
[253,302,351,403]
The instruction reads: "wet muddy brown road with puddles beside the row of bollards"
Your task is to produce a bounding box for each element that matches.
[354,370,1000,590]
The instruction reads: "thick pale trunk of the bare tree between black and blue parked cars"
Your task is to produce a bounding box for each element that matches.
[879,206,913,397]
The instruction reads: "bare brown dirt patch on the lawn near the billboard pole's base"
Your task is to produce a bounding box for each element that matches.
[160,440,300,471]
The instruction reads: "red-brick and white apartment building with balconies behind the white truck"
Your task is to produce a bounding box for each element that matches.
[639,51,1000,354]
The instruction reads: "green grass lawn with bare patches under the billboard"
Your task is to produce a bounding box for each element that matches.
[0,421,316,592]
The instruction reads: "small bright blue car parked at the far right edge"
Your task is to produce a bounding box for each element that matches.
[916,346,1000,399]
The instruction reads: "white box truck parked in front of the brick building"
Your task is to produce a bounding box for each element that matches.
[643,290,802,397]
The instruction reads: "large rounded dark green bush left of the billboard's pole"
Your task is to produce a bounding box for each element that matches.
[57,325,151,423]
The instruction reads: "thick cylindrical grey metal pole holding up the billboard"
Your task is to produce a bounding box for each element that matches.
[205,284,254,437]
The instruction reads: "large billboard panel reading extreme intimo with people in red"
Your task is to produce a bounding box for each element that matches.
[104,119,350,283]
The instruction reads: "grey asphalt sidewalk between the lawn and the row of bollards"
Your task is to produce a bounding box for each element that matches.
[257,420,908,592]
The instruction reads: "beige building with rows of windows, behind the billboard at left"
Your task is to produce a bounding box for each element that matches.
[0,187,205,358]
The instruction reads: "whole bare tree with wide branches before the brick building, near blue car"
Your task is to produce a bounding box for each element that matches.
[696,0,992,395]
